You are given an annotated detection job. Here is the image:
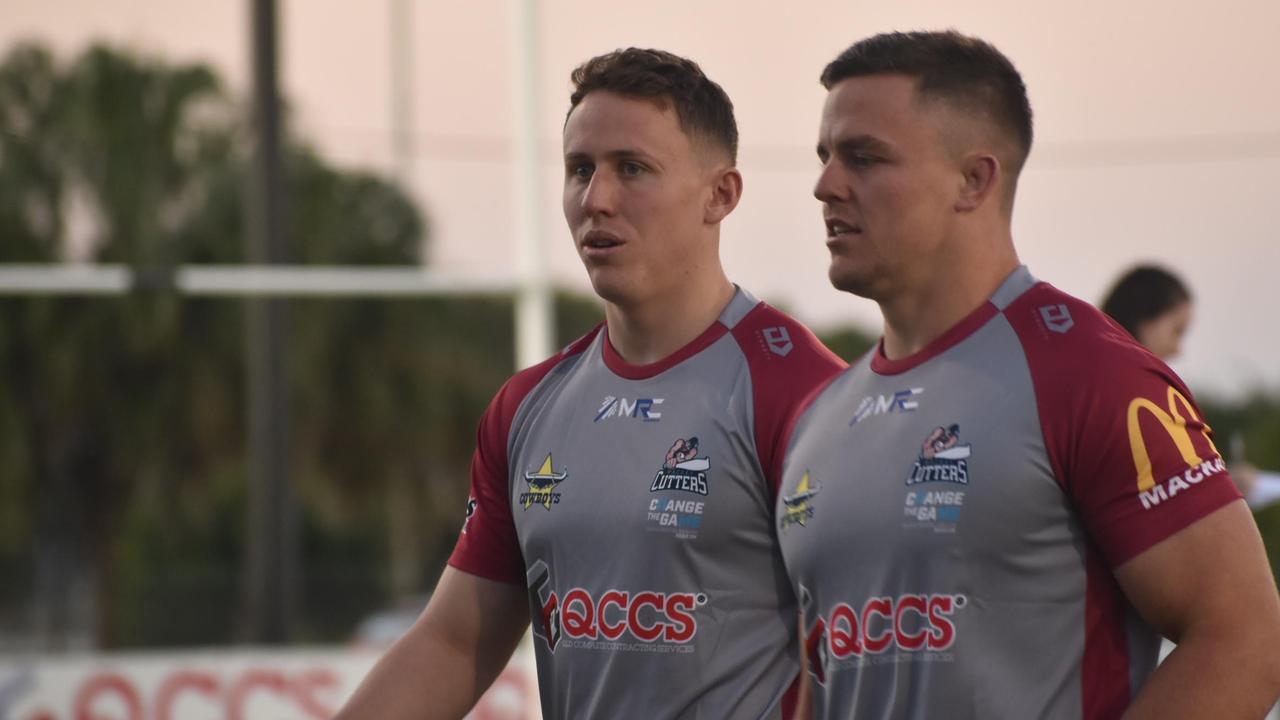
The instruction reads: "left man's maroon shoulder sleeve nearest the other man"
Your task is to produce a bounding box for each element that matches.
[733,302,847,496]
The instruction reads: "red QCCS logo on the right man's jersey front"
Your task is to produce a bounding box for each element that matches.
[804,594,968,683]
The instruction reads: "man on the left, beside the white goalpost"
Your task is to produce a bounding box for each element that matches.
[339,49,844,720]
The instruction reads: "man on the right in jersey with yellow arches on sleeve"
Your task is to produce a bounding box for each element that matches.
[777,31,1280,720]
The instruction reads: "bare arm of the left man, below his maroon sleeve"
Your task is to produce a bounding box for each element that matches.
[335,568,529,720]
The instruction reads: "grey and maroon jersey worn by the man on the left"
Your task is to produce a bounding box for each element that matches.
[449,290,845,719]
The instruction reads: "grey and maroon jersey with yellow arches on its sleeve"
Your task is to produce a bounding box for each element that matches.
[777,268,1239,720]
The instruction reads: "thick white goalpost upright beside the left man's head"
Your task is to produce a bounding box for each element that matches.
[509,0,554,369]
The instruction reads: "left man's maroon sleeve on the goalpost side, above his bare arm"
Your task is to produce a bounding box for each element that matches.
[449,327,600,585]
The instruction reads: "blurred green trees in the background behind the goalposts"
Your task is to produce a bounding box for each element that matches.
[0,45,1280,650]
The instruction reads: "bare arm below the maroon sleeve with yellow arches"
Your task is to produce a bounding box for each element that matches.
[1116,501,1280,719]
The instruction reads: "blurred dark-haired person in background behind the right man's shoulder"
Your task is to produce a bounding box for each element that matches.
[1100,265,1280,510]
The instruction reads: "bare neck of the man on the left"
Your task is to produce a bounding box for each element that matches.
[604,270,736,365]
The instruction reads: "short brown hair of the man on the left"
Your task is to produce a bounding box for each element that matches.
[566,47,737,164]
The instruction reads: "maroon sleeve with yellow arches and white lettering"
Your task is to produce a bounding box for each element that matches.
[1005,283,1240,568]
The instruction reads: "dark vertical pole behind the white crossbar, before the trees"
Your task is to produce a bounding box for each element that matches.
[242,0,296,643]
